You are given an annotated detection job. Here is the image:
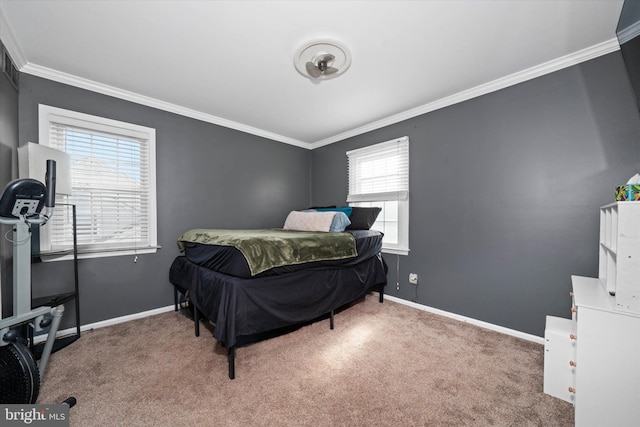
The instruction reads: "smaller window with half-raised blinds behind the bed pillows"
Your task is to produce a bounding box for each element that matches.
[347,136,409,255]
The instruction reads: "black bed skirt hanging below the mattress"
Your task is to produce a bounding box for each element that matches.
[169,254,387,348]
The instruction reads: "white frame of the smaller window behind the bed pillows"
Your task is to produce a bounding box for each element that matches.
[347,136,409,255]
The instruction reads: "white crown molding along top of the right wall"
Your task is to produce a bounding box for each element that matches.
[311,38,620,149]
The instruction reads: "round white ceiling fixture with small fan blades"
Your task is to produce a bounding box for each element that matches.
[293,40,351,80]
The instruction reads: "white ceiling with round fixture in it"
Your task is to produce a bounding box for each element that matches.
[0,0,623,149]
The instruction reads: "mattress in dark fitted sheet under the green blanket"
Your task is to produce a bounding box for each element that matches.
[184,230,383,278]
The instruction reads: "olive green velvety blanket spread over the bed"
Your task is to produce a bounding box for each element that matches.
[178,228,358,276]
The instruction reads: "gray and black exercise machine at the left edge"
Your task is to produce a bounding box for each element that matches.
[0,160,75,406]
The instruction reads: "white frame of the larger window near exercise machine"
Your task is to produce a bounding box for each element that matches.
[38,104,159,261]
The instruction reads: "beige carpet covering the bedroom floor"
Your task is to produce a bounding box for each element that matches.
[38,295,573,427]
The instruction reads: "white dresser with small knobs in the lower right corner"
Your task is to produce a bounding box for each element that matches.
[544,276,640,427]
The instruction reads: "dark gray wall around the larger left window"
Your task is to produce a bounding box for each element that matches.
[19,74,311,324]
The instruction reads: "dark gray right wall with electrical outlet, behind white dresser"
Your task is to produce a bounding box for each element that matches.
[312,52,640,336]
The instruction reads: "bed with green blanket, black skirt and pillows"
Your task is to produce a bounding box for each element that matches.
[169,207,387,379]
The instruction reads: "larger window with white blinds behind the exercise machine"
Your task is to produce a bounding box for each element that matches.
[39,105,157,257]
